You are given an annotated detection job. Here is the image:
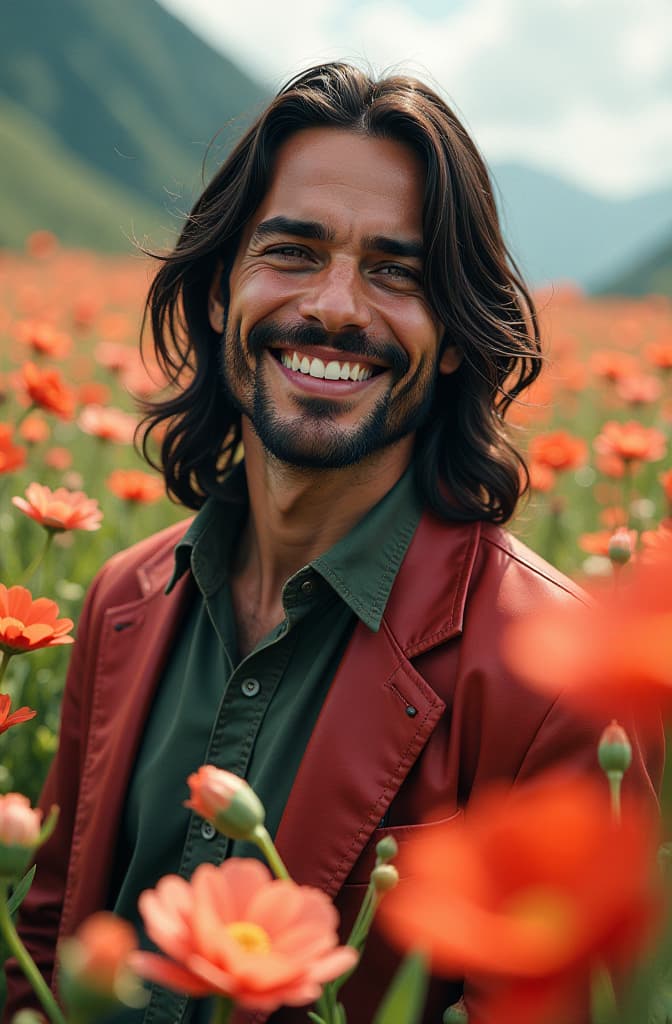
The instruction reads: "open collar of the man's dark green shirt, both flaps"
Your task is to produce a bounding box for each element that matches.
[166,464,422,632]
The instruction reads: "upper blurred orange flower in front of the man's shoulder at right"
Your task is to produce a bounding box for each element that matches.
[503,544,672,730]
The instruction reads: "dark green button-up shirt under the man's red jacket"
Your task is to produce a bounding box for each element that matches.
[111,466,421,1024]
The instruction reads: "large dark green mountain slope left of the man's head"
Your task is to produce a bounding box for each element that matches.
[0,0,265,250]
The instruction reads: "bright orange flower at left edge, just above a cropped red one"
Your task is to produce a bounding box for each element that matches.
[0,583,75,654]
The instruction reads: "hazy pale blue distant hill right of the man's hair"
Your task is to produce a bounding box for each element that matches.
[493,164,672,290]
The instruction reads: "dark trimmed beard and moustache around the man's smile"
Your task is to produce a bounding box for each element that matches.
[220,324,436,469]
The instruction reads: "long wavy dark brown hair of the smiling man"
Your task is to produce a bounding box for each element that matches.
[142,62,542,522]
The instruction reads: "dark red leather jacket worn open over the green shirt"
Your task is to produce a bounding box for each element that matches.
[3,514,662,1024]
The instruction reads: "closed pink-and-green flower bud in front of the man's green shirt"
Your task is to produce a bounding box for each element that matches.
[184,765,265,839]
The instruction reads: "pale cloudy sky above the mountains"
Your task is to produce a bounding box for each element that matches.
[161,0,672,197]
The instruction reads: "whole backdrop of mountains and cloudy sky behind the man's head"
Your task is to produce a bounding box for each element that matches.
[0,0,672,296]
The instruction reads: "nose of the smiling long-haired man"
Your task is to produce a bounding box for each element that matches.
[298,263,372,332]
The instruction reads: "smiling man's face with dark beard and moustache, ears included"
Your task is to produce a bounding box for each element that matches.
[211,128,459,468]
